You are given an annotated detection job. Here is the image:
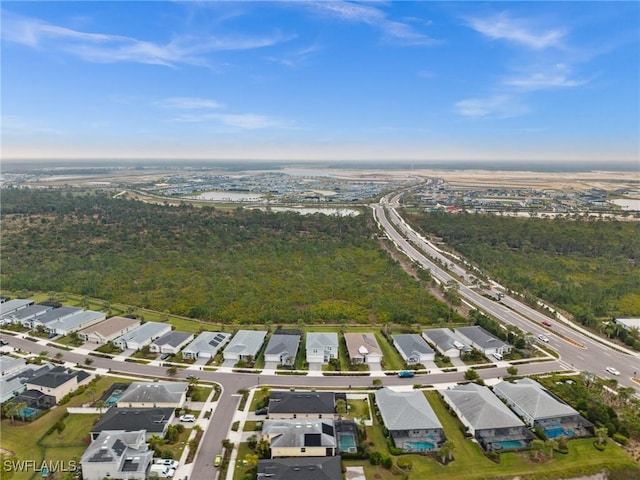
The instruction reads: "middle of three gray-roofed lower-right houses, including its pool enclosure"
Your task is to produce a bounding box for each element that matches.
[440,383,535,451]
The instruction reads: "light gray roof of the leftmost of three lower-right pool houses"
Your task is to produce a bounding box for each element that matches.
[376,388,442,430]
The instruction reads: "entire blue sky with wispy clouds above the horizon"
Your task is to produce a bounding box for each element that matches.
[1,1,640,162]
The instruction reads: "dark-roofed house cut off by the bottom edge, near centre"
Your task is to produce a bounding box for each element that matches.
[258,457,342,480]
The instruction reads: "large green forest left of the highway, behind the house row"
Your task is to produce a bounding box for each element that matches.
[0,189,462,324]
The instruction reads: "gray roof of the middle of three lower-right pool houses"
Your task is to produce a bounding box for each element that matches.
[441,383,524,430]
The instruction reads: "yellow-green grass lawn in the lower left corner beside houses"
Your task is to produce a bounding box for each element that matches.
[0,377,131,480]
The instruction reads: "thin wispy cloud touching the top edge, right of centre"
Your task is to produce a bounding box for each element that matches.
[300,1,440,45]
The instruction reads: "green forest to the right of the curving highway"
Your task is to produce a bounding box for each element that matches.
[407,213,640,326]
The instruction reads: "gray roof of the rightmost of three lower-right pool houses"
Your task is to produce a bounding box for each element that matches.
[493,378,579,420]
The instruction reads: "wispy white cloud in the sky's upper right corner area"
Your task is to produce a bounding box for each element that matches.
[467,12,565,50]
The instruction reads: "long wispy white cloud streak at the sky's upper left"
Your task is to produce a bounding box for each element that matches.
[2,11,290,66]
